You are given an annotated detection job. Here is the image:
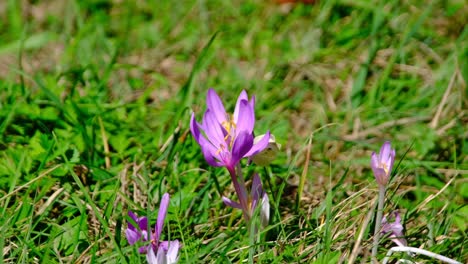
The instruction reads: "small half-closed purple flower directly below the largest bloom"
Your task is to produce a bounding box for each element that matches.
[223,174,270,227]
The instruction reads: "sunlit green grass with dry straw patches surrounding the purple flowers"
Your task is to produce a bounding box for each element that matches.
[0,0,468,263]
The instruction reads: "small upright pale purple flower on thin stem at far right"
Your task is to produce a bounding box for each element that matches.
[371,141,395,186]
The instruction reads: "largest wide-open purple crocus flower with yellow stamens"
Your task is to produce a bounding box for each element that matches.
[190,89,270,173]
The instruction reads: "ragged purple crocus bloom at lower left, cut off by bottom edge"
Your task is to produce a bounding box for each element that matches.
[125,193,179,263]
